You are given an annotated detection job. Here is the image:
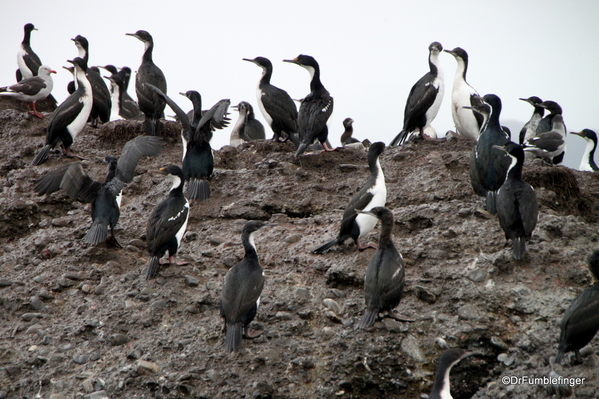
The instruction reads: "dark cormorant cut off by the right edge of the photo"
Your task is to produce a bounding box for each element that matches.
[555,250,599,364]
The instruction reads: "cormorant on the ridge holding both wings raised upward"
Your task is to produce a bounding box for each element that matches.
[147,84,231,201]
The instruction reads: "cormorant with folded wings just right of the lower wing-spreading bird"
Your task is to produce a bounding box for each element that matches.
[146,165,189,280]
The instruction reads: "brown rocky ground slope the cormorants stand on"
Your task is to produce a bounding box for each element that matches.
[0,97,599,399]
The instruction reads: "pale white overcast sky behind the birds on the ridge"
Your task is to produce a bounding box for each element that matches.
[0,0,599,168]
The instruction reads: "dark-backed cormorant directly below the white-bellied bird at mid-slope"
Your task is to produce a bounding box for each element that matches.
[358,206,405,328]
